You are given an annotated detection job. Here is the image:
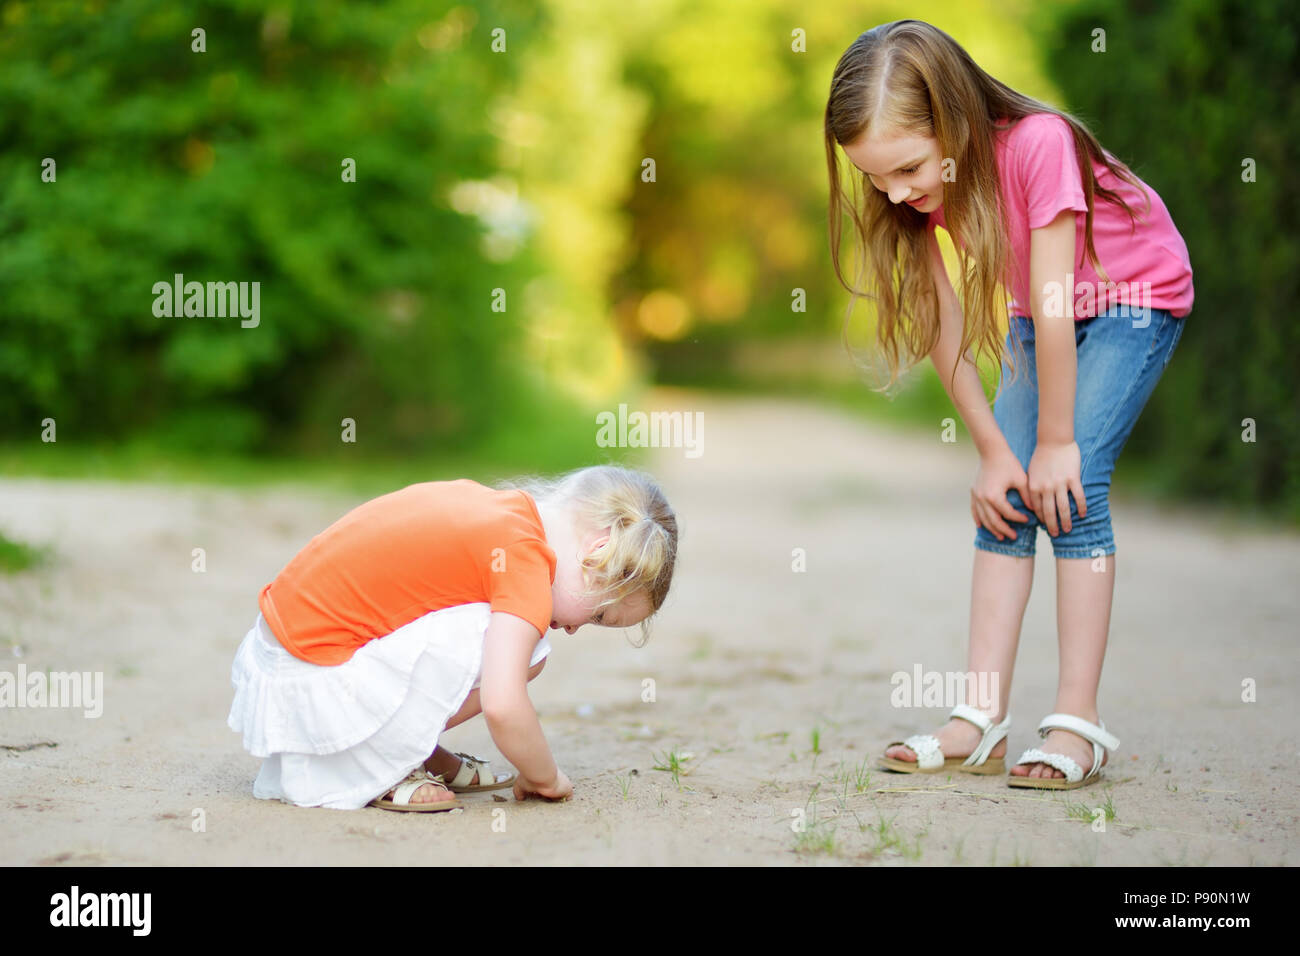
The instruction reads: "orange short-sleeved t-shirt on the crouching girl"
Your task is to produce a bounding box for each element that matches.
[257,479,555,665]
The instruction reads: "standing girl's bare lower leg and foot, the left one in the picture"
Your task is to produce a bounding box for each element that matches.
[885,548,1034,761]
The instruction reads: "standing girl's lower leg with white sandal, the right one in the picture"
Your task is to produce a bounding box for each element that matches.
[1011,554,1115,777]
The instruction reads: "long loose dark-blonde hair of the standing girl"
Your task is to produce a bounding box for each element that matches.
[824,20,1151,392]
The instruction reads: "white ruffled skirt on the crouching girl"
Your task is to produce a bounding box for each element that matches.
[228,604,551,810]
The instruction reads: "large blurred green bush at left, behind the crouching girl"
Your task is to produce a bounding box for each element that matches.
[0,0,551,451]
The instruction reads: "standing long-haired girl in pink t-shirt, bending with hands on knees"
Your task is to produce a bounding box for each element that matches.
[826,20,1192,790]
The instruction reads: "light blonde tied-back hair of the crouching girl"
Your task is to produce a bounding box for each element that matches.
[497,464,677,646]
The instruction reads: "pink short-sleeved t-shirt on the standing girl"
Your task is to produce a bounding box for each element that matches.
[930,113,1192,319]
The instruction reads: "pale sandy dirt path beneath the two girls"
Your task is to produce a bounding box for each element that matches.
[0,392,1300,865]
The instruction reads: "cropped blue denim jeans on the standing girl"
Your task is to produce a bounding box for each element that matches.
[975,306,1186,558]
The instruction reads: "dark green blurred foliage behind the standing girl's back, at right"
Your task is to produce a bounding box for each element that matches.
[1040,0,1300,520]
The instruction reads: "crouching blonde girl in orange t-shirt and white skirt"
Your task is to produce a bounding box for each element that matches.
[229,466,677,812]
